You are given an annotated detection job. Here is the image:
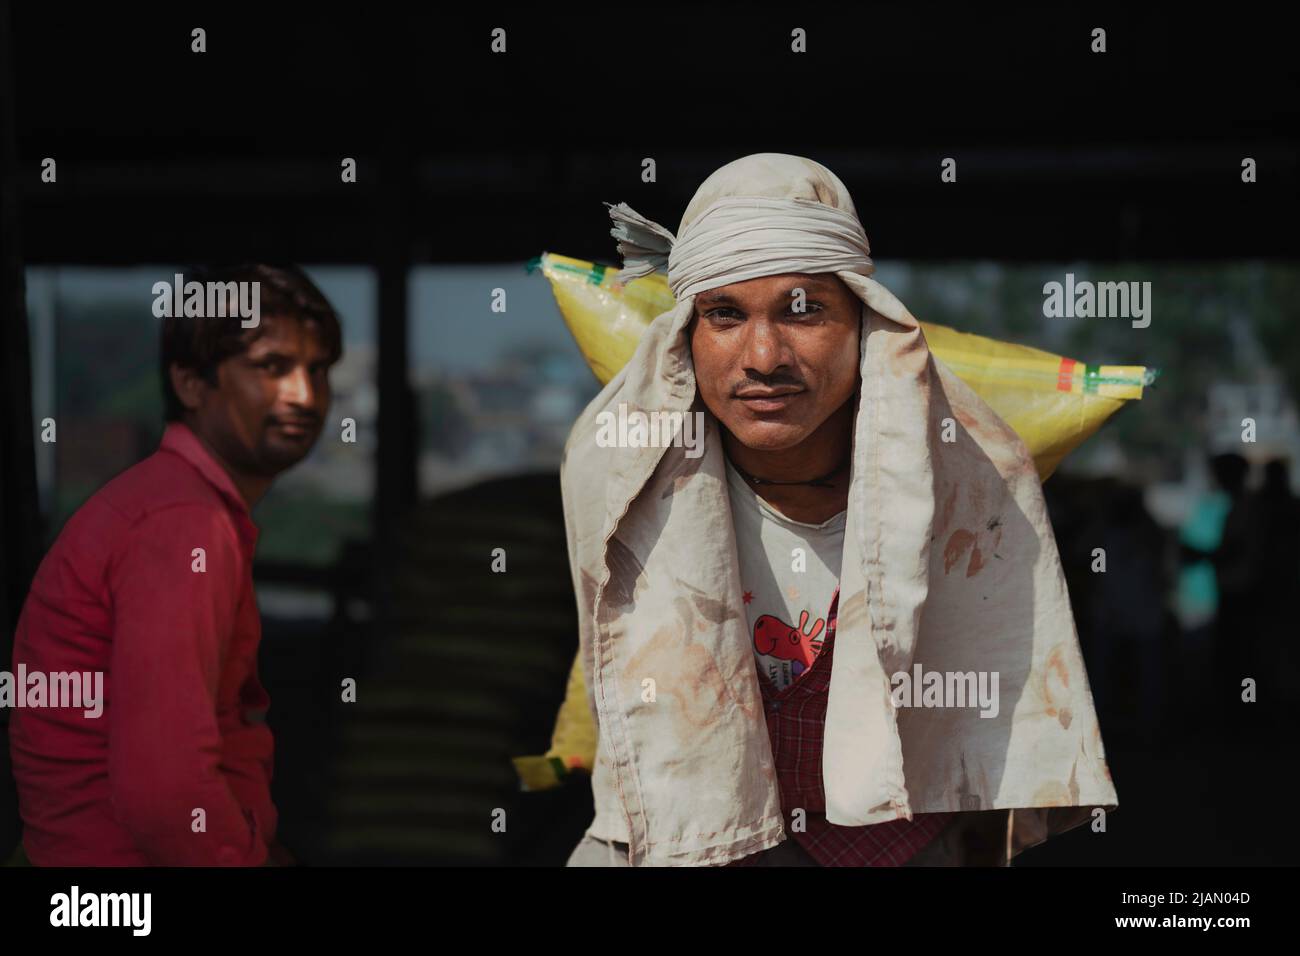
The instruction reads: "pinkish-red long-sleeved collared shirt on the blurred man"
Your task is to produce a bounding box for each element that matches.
[9,423,277,866]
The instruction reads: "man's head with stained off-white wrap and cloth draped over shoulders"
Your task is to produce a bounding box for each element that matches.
[562,153,1118,865]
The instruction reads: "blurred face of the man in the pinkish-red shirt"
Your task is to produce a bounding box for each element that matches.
[185,316,330,477]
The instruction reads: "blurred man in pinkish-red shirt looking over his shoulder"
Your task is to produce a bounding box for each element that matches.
[9,264,342,866]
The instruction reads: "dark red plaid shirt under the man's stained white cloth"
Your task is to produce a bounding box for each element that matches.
[727,588,953,866]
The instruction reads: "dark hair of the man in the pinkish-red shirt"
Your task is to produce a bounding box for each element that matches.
[160,263,343,421]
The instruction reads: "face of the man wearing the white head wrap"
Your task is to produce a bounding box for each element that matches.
[689,273,862,451]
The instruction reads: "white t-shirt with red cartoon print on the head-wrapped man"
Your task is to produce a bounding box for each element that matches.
[727,462,849,691]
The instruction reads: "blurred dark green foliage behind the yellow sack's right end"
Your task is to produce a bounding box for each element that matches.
[896,261,1300,479]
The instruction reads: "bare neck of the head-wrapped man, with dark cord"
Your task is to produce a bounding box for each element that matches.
[723,401,855,524]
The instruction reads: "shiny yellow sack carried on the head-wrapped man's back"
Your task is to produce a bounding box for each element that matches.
[514,252,1158,790]
